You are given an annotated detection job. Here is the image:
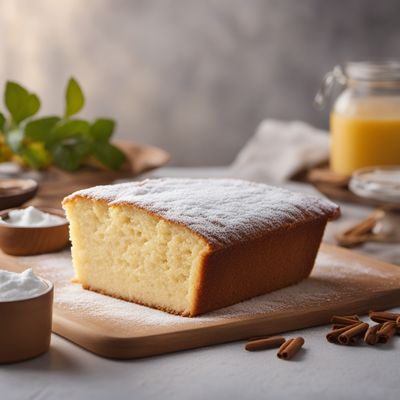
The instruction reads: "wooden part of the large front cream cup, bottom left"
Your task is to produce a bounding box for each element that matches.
[0,279,54,364]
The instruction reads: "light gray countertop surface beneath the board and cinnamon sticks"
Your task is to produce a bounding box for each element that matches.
[0,168,400,400]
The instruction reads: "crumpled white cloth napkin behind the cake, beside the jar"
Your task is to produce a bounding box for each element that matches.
[229,119,329,182]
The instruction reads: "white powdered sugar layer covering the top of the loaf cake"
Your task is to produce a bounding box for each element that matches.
[65,178,338,247]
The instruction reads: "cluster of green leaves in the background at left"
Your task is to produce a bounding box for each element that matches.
[0,78,122,171]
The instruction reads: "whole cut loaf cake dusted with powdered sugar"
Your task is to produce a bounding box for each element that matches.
[63,178,339,316]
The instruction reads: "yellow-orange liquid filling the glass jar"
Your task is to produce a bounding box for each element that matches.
[330,97,400,175]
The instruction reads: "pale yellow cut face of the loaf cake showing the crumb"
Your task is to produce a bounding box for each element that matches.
[64,198,209,314]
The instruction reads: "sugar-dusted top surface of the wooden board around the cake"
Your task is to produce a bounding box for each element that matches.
[18,251,399,333]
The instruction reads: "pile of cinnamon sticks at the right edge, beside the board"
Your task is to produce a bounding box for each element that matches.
[326,311,400,345]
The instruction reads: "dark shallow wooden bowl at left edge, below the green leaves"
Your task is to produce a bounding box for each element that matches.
[0,179,39,210]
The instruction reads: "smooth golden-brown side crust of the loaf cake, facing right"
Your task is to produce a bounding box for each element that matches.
[190,220,326,316]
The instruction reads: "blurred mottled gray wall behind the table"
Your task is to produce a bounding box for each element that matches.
[0,0,400,165]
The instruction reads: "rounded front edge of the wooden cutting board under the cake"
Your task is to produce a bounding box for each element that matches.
[53,288,400,360]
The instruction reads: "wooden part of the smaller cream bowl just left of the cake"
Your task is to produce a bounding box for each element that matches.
[0,207,69,256]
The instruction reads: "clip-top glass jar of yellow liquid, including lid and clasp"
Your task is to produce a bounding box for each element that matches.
[315,61,400,175]
